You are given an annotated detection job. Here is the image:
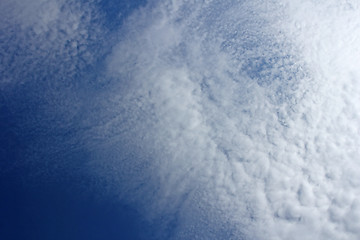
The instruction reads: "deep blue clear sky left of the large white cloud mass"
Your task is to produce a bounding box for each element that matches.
[0,1,151,240]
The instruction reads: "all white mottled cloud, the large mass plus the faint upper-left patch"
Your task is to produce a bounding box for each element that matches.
[1,0,360,240]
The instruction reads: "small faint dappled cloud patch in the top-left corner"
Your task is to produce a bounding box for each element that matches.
[1,0,102,88]
